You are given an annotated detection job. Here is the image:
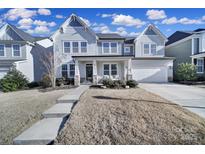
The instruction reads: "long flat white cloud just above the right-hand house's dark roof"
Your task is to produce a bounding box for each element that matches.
[162,17,204,25]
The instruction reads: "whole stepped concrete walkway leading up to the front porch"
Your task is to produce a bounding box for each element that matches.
[14,85,89,145]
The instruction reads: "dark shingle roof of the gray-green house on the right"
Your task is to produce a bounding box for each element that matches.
[166,31,193,46]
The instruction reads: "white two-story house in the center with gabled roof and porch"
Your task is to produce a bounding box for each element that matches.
[50,14,173,85]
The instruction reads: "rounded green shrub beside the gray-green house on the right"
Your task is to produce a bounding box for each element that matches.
[176,63,197,81]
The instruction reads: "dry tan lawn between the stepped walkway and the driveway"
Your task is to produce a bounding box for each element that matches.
[55,88,205,144]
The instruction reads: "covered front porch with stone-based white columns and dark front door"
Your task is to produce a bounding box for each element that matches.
[73,56,132,85]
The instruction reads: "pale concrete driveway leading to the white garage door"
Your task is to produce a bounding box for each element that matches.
[139,83,205,118]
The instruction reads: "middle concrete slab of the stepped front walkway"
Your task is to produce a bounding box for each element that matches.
[42,103,73,118]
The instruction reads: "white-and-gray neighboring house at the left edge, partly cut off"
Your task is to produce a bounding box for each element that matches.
[0,24,52,82]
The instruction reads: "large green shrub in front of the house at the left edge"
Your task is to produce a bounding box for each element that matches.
[0,68,28,92]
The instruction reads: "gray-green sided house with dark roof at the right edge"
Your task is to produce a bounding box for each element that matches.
[165,29,205,76]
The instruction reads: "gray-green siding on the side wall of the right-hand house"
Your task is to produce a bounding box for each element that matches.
[165,40,192,73]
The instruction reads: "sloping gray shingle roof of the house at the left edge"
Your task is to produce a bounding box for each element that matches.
[8,24,35,42]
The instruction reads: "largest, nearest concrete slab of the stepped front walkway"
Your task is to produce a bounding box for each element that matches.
[14,118,64,145]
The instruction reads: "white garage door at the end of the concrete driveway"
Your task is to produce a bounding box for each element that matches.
[132,60,168,82]
